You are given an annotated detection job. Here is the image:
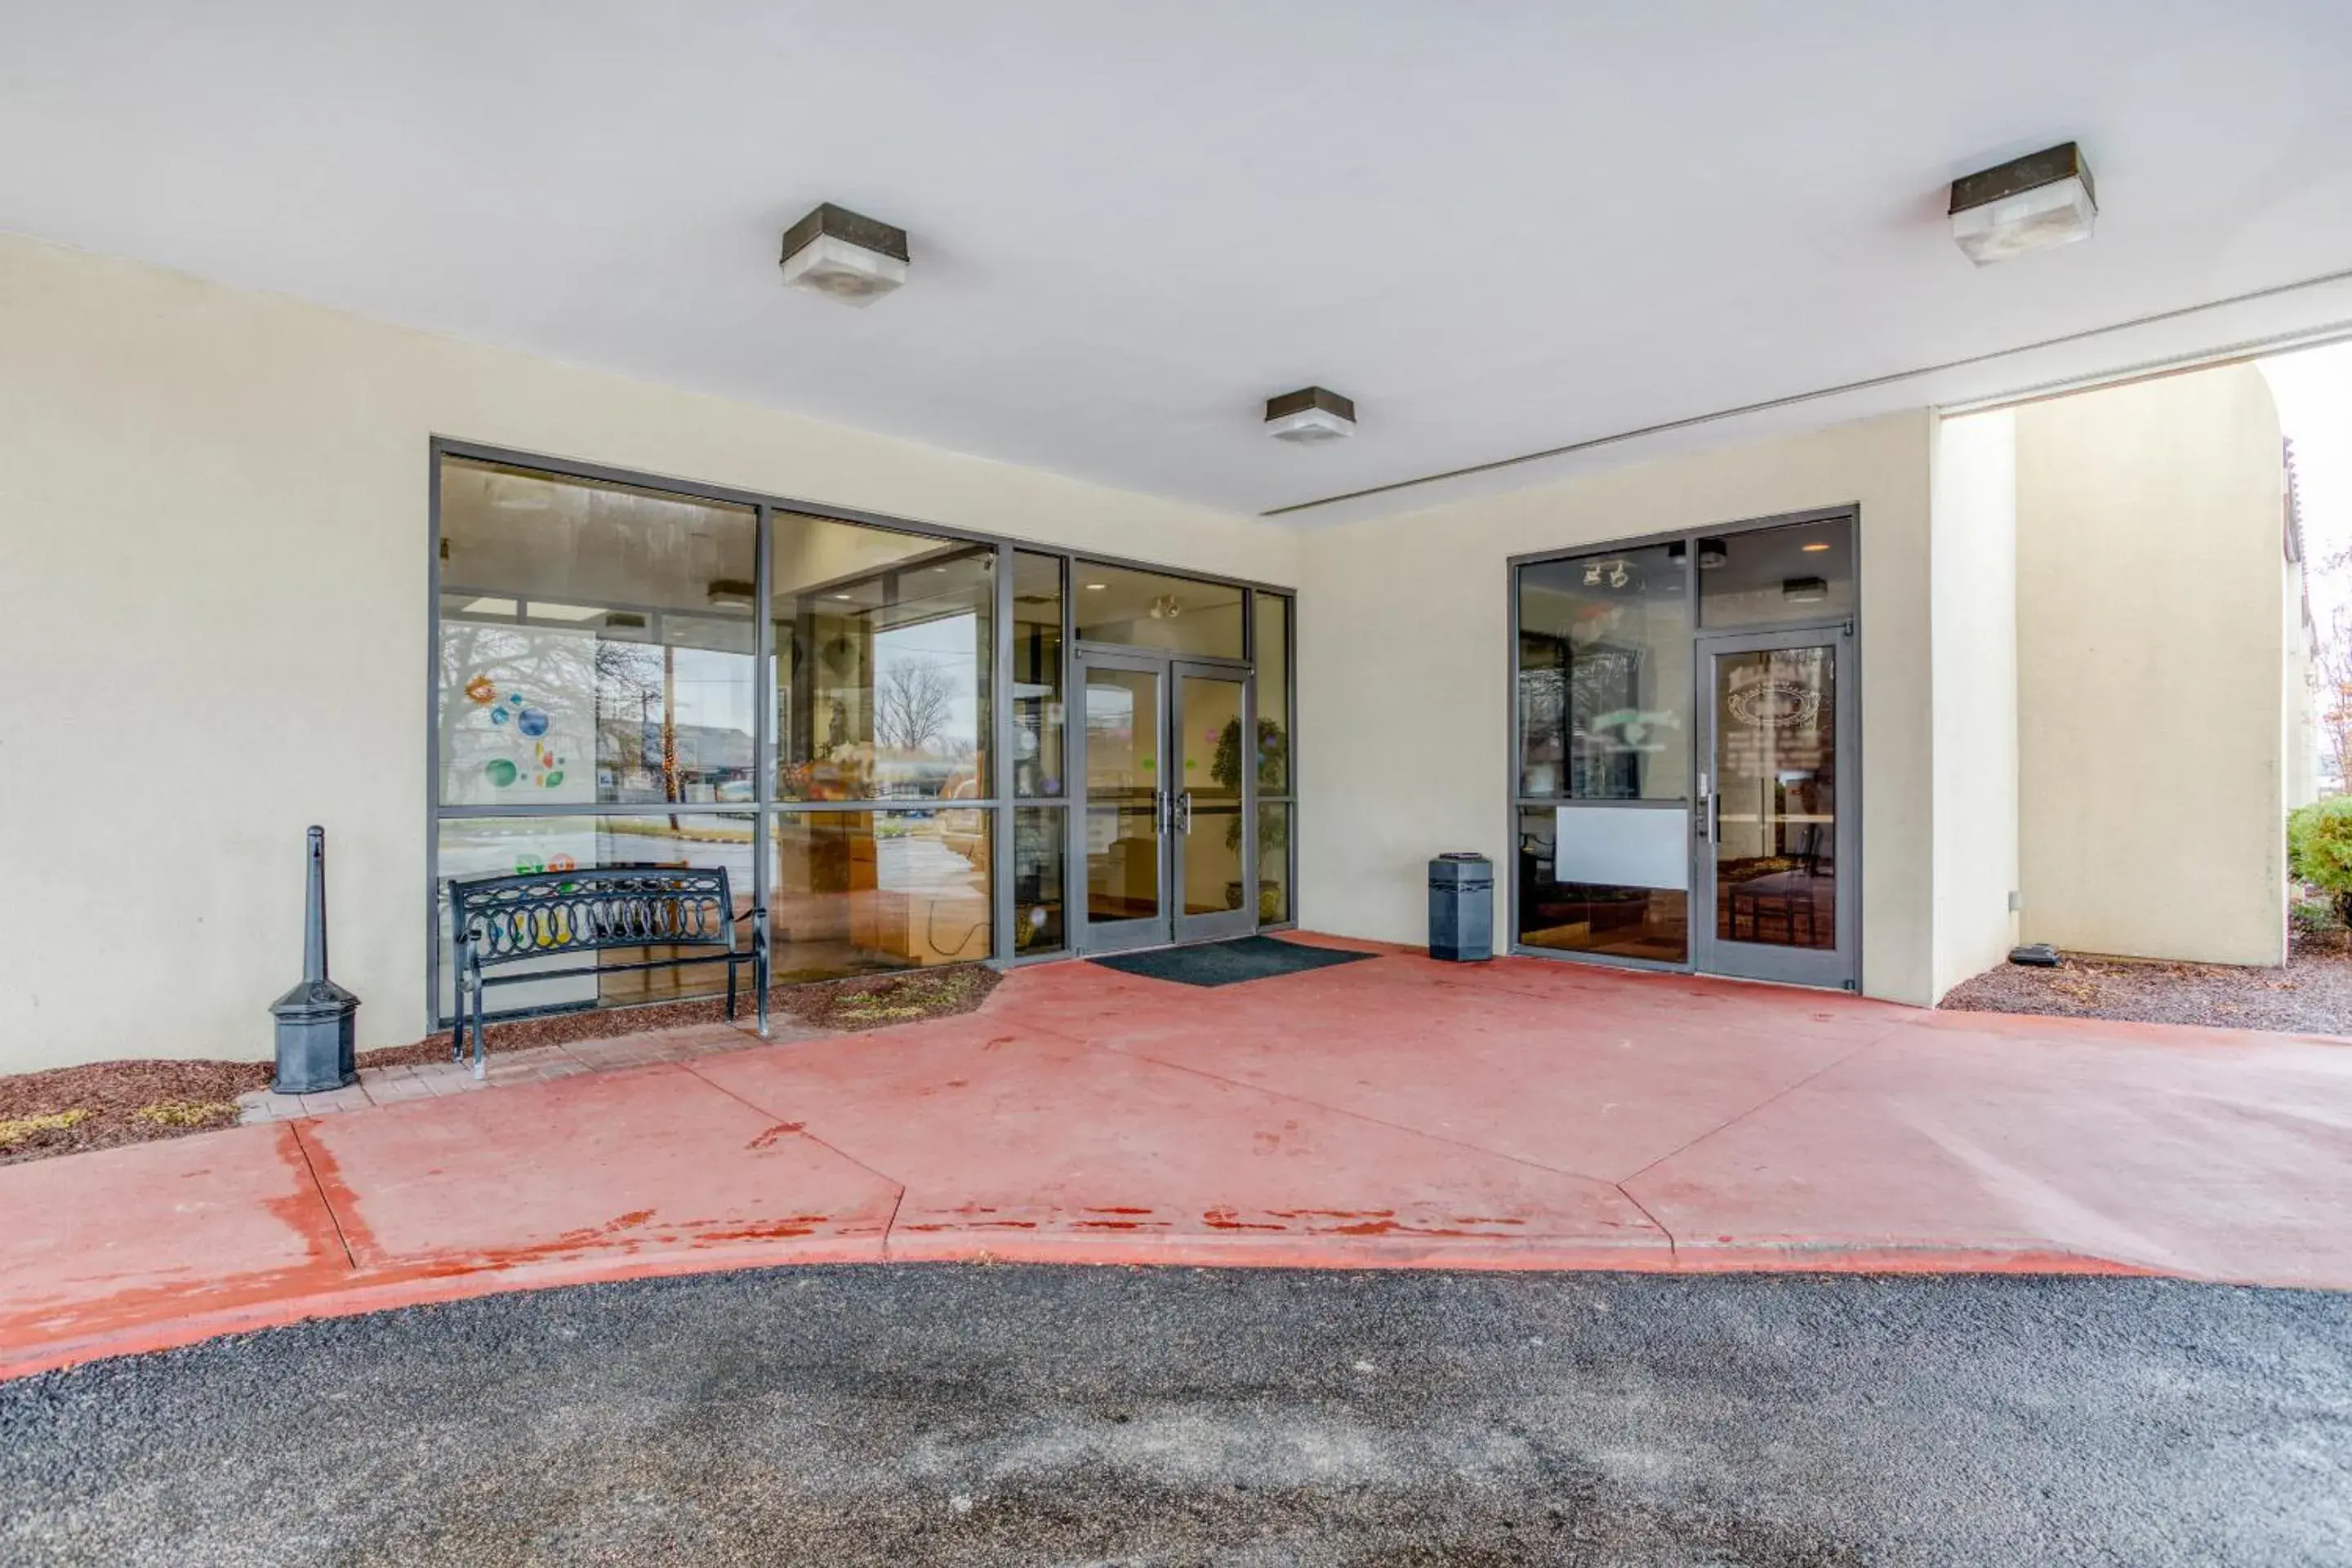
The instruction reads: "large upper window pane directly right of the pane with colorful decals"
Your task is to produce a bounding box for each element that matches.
[774,513,997,800]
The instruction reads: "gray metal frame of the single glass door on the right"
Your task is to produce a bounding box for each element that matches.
[1691,621,1863,990]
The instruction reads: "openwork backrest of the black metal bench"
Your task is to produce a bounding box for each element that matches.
[449,865,734,964]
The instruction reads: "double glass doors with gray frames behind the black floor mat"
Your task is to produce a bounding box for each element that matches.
[1070,648,1258,952]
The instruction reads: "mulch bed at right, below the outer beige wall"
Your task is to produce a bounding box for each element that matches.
[1943,933,2352,1035]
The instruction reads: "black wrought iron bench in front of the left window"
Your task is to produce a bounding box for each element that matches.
[449,865,769,1076]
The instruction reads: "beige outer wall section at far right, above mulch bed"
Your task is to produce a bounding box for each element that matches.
[2016,367,2288,964]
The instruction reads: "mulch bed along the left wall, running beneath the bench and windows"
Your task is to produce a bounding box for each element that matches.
[0,964,1004,1166]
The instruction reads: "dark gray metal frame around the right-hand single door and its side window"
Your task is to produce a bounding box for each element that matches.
[1505,501,1865,992]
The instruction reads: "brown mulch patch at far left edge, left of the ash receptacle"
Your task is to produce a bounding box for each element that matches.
[0,1060,270,1166]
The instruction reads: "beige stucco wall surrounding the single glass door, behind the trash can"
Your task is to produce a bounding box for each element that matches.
[1298,412,1936,1001]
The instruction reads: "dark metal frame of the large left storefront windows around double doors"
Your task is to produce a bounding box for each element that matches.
[423,435,1298,1027]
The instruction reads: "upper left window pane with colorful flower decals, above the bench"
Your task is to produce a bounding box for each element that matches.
[435,458,757,806]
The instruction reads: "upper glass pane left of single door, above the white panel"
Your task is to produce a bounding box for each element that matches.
[1517,543,1691,800]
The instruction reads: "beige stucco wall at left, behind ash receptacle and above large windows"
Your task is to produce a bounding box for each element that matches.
[0,238,1301,1072]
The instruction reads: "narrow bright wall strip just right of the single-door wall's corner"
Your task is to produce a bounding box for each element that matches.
[1931,412,2018,997]
